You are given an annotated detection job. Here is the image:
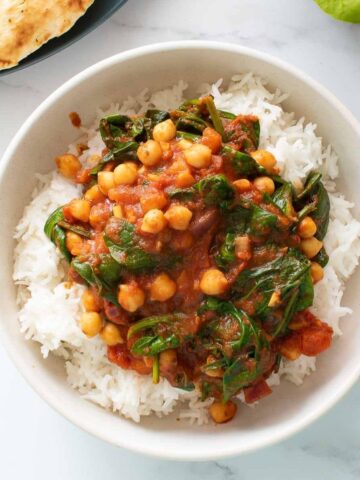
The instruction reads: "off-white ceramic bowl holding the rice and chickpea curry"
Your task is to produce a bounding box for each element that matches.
[0,41,360,460]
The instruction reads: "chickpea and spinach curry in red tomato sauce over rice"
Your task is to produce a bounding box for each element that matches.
[45,96,332,423]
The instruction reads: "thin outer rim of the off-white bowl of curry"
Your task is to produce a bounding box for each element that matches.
[0,40,360,460]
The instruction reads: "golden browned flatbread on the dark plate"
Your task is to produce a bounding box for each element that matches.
[0,0,94,70]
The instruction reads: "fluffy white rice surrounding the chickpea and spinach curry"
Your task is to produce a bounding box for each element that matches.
[13,73,360,424]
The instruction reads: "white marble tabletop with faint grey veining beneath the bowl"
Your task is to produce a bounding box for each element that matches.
[0,0,360,480]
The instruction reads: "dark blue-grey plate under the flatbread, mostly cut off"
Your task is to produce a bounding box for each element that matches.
[0,0,127,76]
